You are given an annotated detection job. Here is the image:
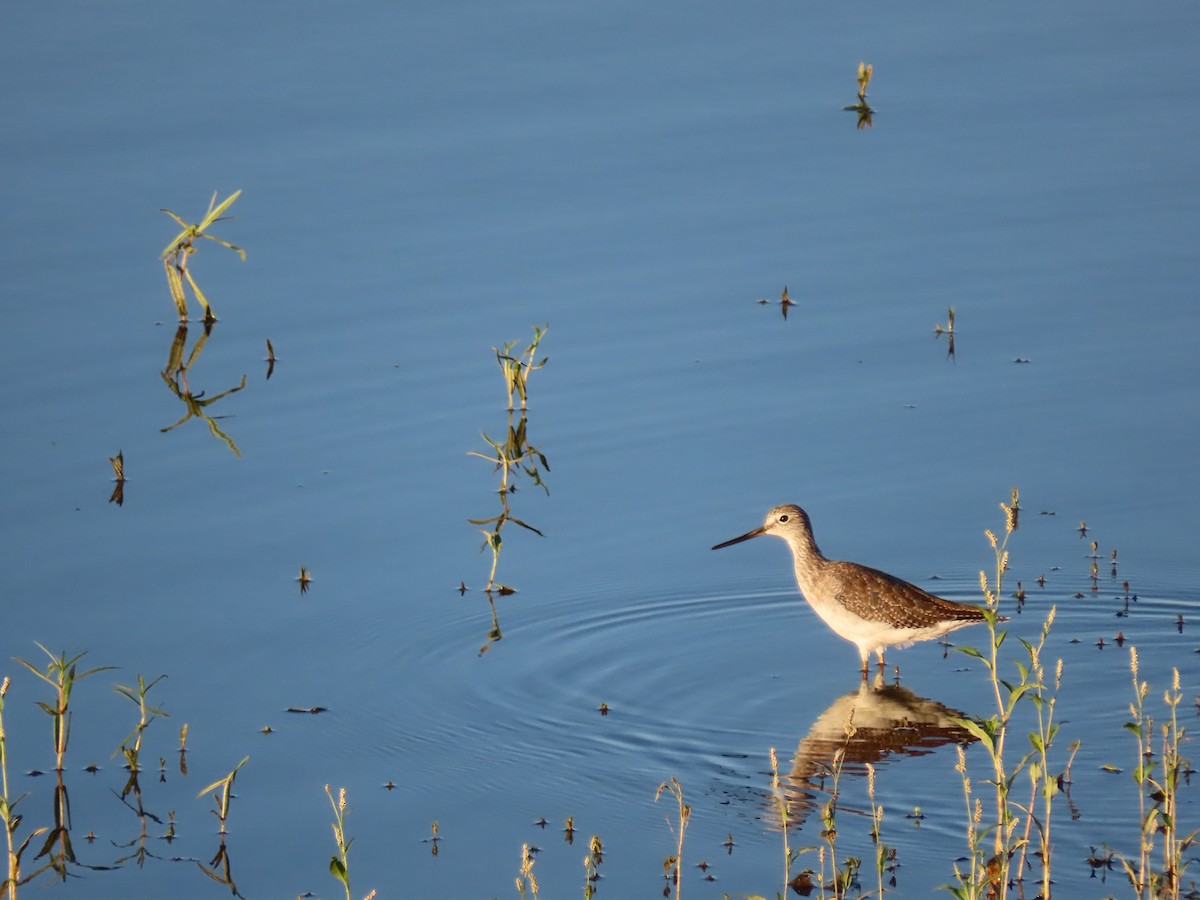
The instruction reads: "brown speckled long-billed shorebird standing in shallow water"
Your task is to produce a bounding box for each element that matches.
[713,503,1004,676]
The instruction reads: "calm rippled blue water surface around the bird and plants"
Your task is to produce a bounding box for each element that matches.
[0,2,1200,898]
